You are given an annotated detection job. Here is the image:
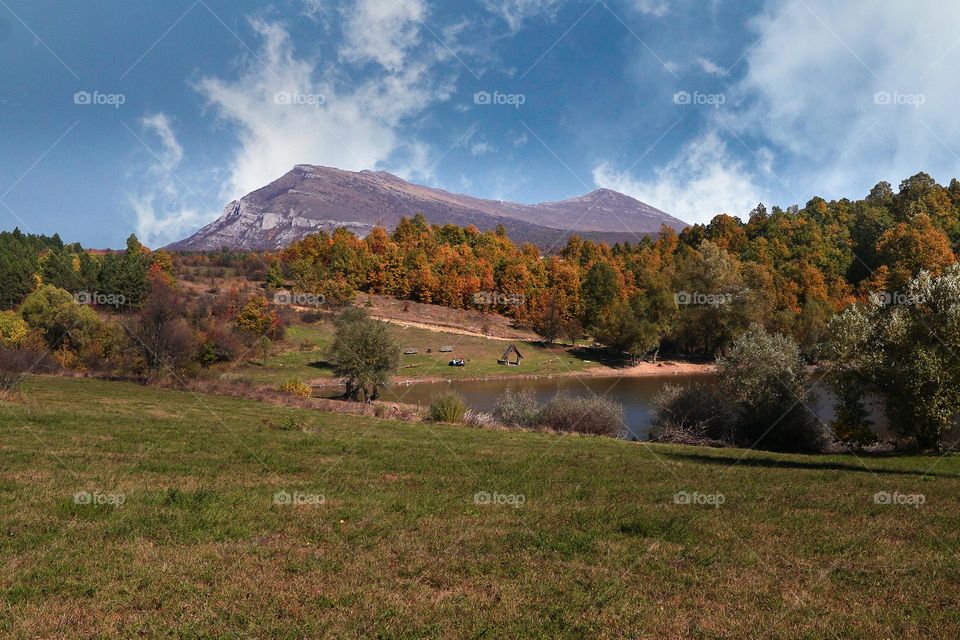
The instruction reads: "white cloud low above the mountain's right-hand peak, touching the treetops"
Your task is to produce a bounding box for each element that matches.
[593,132,764,224]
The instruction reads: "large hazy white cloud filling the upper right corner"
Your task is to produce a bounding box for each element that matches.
[727,0,960,199]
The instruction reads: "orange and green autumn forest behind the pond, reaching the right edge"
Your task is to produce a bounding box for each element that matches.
[276,173,960,359]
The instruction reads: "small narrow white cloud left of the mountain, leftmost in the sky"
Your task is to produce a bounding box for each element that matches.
[127,113,206,247]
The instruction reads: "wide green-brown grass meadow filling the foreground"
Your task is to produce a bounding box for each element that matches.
[0,378,960,639]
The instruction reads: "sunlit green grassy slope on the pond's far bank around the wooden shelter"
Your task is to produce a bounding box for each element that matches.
[223,322,591,384]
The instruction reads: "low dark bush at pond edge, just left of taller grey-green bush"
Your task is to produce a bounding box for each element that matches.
[650,384,734,443]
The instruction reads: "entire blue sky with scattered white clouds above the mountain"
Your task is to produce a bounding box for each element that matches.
[0,0,960,247]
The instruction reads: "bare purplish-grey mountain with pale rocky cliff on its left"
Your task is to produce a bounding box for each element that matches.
[167,164,687,251]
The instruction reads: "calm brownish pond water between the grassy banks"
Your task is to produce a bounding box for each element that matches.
[381,374,713,440]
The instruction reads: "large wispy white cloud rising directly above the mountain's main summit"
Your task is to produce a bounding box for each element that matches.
[197,16,450,200]
